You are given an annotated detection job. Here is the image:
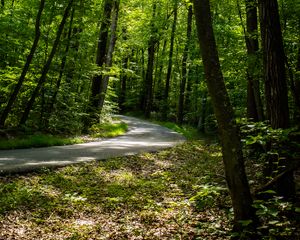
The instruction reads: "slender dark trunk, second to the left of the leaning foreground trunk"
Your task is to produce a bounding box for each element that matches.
[162,1,178,119]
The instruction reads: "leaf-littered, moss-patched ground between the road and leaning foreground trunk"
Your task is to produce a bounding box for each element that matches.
[0,141,231,240]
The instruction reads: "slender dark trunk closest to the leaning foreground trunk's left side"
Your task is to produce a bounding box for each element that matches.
[177,6,193,125]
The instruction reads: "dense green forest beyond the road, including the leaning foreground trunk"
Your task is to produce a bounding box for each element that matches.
[0,0,300,237]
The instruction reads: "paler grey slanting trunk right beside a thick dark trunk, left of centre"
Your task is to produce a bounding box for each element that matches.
[99,0,120,114]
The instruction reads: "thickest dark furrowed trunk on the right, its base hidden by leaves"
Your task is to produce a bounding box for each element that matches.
[259,0,295,198]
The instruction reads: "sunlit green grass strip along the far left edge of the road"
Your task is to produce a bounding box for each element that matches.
[0,122,127,150]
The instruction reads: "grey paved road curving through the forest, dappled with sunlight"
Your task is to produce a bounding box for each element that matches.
[0,116,185,174]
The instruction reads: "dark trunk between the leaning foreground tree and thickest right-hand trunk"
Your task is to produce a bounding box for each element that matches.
[245,0,263,121]
